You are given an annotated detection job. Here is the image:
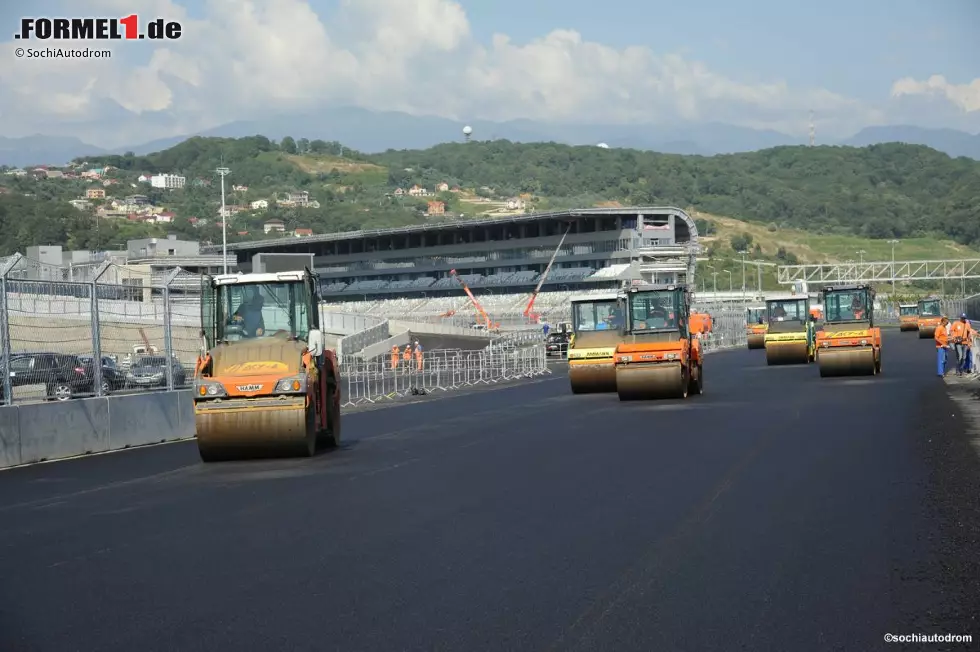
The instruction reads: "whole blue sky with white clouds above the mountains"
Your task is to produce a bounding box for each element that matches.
[0,0,980,147]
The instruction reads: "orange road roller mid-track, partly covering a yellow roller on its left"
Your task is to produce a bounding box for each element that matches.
[614,285,704,401]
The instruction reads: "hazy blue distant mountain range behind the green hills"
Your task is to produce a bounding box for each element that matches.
[0,107,980,167]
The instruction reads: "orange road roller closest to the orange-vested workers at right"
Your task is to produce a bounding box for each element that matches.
[817,284,881,376]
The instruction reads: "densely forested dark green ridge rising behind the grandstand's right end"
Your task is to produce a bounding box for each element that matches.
[369,141,980,244]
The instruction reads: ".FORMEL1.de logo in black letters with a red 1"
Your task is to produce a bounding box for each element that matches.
[14,14,182,41]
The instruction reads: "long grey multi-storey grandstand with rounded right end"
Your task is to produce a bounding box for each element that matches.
[218,207,699,302]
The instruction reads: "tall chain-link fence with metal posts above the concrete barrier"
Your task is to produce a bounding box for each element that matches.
[0,254,200,404]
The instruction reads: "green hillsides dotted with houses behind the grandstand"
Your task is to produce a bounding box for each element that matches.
[0,136,980,262]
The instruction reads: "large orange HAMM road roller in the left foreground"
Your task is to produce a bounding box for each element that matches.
[194,269,340,462]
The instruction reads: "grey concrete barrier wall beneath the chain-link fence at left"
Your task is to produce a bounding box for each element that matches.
[0,390,195,468]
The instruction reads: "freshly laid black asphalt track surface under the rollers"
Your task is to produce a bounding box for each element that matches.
[0,332,980,652]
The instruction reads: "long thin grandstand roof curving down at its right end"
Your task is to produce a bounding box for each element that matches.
[209,206,698,252]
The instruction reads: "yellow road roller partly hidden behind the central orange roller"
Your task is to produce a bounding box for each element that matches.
[567,292,626,394]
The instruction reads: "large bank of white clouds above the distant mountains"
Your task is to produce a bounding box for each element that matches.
[0,0,964,146]
